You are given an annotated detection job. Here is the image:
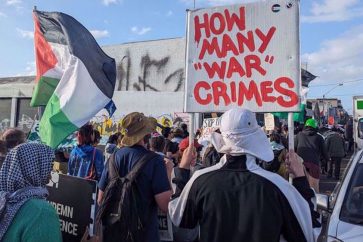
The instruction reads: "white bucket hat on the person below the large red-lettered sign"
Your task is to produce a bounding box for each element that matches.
[211,108,274,162]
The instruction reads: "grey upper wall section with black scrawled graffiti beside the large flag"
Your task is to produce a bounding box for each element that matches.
[104,39,185,92]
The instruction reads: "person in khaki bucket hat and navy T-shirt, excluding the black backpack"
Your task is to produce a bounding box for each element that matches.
[98,112,171,242]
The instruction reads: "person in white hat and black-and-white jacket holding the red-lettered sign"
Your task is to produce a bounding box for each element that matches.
[169,108,320,242]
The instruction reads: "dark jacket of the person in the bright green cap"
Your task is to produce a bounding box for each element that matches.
[295,127,330,165]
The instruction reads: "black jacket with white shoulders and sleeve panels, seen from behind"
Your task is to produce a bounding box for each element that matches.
[169,156,320,242]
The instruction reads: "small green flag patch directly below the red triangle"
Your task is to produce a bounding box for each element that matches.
[30,76,59,107]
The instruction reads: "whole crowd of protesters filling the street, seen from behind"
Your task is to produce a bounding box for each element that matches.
[0,108,351,242]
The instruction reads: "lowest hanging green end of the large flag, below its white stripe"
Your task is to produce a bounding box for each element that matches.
[39,94,78,148]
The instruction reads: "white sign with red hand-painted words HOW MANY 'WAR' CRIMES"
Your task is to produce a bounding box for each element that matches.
[184,0,300,112]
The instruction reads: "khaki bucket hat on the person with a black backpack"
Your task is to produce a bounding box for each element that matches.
[121,112,157,146]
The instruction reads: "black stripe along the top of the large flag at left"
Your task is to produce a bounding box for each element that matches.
[34,11,116,99]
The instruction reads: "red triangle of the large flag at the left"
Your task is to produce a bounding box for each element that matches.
[33,13,58,82]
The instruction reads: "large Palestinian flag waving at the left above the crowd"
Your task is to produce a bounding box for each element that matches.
[32,11,116,148]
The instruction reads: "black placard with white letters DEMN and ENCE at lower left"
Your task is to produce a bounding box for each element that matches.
[47,172,96,242]
